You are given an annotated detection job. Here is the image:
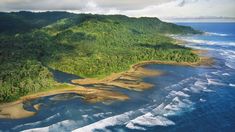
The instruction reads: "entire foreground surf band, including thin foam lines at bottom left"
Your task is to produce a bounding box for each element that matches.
[21,68,230,132]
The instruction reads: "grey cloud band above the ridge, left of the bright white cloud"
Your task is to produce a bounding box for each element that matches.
[0,0,172,10]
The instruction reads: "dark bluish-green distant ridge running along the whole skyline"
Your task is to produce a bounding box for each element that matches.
[0,11,199,34]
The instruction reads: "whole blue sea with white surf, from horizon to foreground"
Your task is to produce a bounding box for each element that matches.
[0,23,235,132]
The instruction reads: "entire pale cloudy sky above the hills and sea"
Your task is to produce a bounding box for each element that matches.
[0,0,235,18]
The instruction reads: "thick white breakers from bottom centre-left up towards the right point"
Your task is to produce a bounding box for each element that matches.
[70,75,218,132]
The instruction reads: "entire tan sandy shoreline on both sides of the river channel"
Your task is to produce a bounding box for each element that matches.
[0,50,213,119]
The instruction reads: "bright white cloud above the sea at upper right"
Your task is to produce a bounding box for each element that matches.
[122,0,235,17]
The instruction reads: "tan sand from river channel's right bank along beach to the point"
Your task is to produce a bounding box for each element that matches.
[72,50,213,91]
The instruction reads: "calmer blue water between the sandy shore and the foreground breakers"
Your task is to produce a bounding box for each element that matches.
[0,60,213,131]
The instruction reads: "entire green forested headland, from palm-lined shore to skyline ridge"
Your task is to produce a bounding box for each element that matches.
[0,12,200,102]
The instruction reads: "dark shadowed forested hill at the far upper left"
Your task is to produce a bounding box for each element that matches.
[0,11,75,34]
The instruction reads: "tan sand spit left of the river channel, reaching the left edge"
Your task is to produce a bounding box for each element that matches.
[0,86,128,119]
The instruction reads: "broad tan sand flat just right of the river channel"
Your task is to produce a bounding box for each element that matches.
[72,65,163,91]
